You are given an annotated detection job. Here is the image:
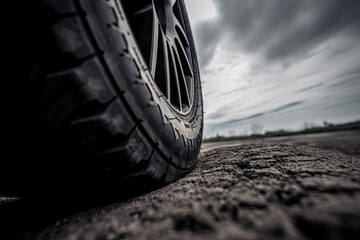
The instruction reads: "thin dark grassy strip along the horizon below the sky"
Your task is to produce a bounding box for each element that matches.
[203,121,360,143]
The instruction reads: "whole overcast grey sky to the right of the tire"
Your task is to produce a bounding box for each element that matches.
[185,0,360,137]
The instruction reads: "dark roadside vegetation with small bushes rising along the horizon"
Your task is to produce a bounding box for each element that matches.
[203,121,360,142]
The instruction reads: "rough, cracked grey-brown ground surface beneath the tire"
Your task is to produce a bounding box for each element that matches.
[0,131,360,239]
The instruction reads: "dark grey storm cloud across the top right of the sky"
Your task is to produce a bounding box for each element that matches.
[195,0,360,66]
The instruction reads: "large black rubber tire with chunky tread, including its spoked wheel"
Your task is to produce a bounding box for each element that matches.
[0,0,203,195]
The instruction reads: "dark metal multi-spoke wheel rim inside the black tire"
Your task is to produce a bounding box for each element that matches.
[122,0,194,114]
